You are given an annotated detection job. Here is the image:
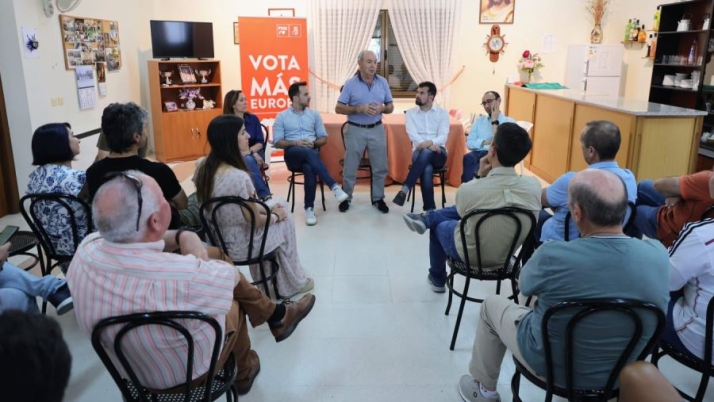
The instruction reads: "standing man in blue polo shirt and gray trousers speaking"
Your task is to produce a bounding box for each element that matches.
[335,50,394,214]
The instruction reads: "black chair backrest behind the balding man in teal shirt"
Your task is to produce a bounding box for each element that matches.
[541,299,665,401]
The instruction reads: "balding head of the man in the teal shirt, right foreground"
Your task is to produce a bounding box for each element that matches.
[568,169,627,227]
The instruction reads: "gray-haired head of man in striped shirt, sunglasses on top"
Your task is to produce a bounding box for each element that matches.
[92,170,160,243]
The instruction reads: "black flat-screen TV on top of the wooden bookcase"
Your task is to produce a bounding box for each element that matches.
[151,20,213,59]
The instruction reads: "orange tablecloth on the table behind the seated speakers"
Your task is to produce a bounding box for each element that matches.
[320,113,468,187]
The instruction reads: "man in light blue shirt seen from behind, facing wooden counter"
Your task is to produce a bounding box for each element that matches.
[536,120,637,242]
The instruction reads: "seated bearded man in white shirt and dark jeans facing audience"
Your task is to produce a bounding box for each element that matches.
[392,81,449,211]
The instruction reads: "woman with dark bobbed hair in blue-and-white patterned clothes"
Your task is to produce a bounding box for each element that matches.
[25,123,87,262]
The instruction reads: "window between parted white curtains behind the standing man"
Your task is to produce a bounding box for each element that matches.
[369,10,417,98]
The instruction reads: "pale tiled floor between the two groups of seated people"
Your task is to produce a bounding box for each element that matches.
[0,164,714,402]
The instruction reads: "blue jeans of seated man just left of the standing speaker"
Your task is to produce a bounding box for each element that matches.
[285,146,337,209]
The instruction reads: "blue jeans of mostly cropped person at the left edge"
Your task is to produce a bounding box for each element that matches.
[0,262,67,314]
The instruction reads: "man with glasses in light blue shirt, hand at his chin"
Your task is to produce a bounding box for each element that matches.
[461,91,516,184]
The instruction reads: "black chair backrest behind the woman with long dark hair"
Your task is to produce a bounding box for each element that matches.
[198,196,270,265]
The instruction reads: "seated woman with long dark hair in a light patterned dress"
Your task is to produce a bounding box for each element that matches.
[195,114,313,297]
